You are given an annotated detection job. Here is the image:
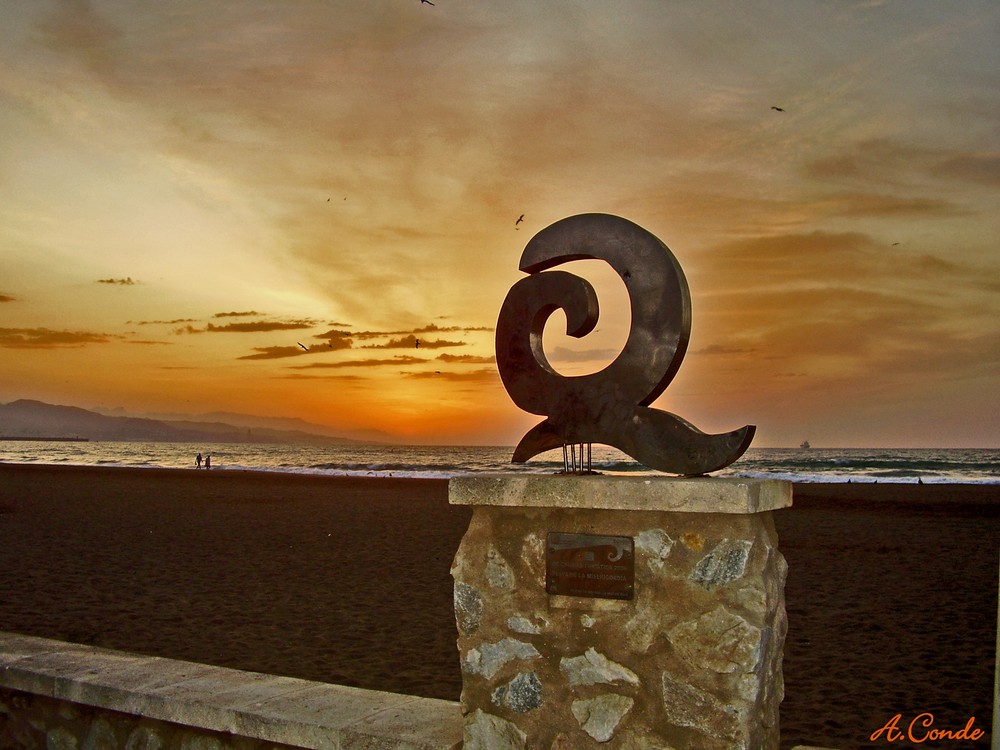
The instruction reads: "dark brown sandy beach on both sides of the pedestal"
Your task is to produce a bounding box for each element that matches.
[0,464,1000,750]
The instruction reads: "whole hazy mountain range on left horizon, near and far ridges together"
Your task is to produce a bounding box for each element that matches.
[0,399,391,445]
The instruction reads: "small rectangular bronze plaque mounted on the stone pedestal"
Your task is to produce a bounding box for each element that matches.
[545,531,635,599]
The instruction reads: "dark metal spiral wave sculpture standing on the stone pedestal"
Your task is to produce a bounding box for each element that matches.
[496,214,756,476]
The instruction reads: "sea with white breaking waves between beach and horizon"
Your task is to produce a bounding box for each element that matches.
[0,440,1000,484]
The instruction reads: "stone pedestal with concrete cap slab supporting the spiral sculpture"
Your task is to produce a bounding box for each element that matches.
[449,475,791,750]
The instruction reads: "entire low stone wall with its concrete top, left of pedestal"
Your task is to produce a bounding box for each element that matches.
[0,633,462,750]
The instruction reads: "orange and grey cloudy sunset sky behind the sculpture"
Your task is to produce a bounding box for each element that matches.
[0,0,1000,447]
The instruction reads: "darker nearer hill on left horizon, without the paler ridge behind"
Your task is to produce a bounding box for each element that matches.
[0,399,353,445]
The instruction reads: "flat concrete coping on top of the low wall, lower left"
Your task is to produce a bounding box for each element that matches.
[0,632,462,750]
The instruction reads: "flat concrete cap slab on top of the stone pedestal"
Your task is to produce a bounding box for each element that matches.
[448,474,792,514]
